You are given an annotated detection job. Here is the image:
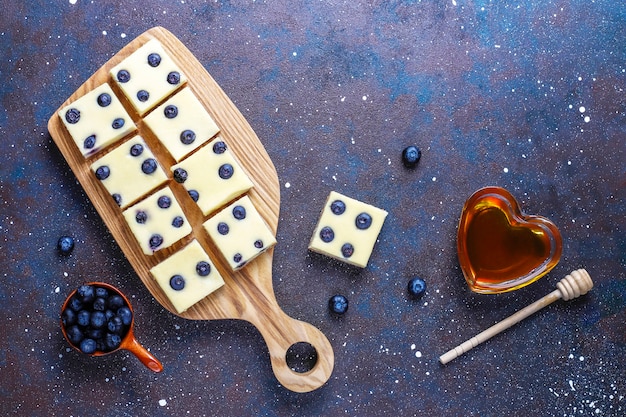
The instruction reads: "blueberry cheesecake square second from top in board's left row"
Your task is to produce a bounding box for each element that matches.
[91,136,167,209]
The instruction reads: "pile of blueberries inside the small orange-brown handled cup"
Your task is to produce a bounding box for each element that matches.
[61,285,133,354]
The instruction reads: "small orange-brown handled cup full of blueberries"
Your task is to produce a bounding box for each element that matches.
[61,282,163,372]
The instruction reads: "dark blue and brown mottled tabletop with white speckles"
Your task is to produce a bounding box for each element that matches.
[0,0,626,416]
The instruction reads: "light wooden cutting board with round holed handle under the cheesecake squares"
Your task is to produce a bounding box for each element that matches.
[48,27,334,392]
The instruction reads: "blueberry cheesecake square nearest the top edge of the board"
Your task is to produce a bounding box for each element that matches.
[110,39,187,116]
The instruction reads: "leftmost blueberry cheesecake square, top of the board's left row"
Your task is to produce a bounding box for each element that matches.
[59,83,137,156]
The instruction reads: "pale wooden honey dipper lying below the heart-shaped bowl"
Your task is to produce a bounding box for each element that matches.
[439,269,593,365]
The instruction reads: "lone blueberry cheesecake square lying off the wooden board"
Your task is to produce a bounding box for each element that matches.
[309,191,387,268]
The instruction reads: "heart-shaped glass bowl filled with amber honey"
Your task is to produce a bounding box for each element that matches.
[457,187,563,294]
